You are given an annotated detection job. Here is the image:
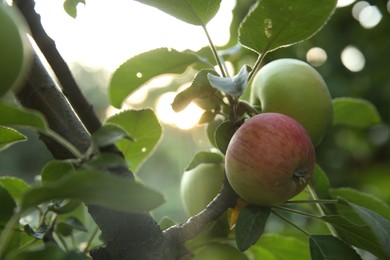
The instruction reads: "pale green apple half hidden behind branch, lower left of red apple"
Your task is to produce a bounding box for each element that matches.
[180,163,225,216]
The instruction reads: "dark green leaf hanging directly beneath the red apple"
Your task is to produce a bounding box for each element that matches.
[236,205,271,251]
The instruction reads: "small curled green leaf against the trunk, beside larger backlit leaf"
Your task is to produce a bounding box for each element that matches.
[92,123,134,147]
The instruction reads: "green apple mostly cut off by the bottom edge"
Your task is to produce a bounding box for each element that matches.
[192,243,248,260]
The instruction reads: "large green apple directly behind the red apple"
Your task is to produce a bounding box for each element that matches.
[251,59,333,146]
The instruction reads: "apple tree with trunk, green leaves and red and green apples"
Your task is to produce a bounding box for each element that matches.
[0,0,390,260]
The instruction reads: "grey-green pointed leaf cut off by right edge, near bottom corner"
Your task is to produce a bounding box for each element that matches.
[347,202,390,258]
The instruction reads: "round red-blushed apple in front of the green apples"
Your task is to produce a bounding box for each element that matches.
[225,113,315,206]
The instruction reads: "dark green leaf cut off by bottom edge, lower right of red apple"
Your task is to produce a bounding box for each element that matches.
[309,235,361,260]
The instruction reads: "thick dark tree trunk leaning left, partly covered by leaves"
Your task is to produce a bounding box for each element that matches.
[15,52,173,260]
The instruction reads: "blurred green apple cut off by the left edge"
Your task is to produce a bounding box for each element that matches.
[0,2,31,96]
